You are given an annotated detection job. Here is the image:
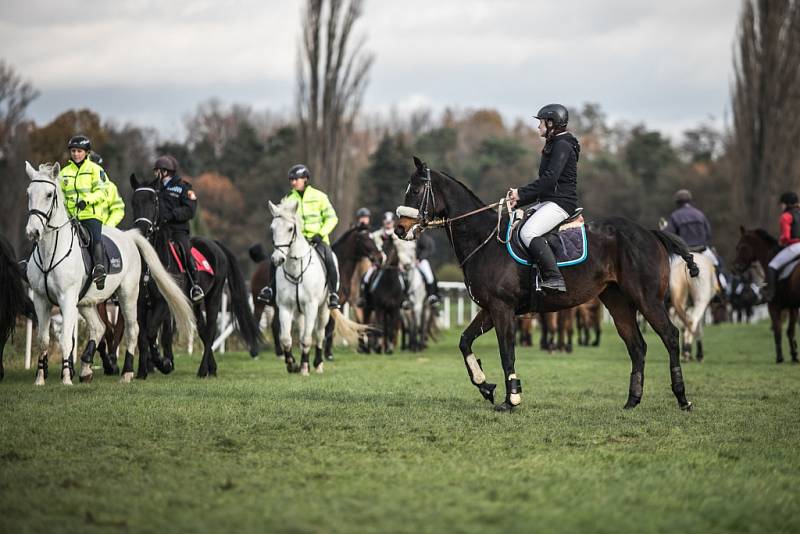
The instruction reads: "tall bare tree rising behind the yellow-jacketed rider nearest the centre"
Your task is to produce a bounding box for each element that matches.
[297,0,374,228]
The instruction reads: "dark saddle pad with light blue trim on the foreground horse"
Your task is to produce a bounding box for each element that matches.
[506,208,589,267]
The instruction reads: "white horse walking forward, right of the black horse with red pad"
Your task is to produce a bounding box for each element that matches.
[269,200,366,376]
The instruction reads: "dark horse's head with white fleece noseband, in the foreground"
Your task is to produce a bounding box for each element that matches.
[394,156,444,241]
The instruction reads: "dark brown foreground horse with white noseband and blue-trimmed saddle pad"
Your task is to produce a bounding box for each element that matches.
[396,157,697,411]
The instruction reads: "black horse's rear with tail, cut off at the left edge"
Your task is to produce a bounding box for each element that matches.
[0,235,36,380]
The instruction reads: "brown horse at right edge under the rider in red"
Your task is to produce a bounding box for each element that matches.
[733,226,800,363]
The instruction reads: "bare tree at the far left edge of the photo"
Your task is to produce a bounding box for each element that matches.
[0,60,38,251]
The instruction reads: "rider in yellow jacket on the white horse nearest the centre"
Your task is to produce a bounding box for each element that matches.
[259,164,339,309]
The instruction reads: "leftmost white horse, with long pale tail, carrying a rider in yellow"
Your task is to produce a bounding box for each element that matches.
[25,162,194,386]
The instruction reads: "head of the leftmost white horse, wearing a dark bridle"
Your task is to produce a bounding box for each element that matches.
[25,161,64,241]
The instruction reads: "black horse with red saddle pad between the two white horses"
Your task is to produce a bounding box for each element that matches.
[131,175,260,378]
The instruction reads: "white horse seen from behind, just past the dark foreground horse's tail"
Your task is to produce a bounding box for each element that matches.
[669,254,719,361]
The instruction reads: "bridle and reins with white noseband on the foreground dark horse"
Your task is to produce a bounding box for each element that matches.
[397,166,512,267]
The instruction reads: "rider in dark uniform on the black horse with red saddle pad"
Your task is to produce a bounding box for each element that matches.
[153,156,205,302]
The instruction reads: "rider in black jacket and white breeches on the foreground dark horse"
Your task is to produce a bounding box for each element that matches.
[509,104,581,291]
